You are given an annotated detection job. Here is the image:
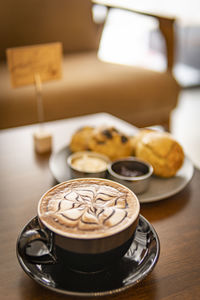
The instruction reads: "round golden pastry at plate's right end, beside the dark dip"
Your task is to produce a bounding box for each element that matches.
[135,131,184,178]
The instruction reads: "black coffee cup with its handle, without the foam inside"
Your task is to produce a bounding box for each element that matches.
[19,178,140,272]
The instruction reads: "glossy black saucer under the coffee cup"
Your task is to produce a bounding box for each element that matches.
[17,215,160,296]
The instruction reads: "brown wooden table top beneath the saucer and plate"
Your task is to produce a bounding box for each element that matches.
[0,113,200,300]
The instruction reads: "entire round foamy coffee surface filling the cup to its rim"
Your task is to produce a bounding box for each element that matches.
[39,179,138,238]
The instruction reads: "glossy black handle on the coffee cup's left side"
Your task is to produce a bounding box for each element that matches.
[17,228,57,264]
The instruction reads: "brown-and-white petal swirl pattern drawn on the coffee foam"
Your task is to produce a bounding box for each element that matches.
[41,182,139,238]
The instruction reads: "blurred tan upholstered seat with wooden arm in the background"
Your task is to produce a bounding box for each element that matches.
[0,0,180,129]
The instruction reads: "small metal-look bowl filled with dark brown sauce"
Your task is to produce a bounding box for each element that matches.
[108,157,153,194]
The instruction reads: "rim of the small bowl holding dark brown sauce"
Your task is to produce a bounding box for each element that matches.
[108,157,153,181]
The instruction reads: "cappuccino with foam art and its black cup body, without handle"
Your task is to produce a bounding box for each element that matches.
[23,178,140,271]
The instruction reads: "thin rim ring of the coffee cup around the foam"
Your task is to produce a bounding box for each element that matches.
[37,177,140,240]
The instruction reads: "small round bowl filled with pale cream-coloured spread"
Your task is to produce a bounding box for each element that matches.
[67,151,110,178]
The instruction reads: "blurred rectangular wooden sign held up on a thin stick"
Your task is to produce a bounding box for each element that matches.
[6,43,62,87]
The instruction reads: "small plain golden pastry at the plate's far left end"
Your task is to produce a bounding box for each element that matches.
[69,126,94,152]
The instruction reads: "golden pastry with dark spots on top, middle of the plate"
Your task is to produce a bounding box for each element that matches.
[88,127,132,160]
